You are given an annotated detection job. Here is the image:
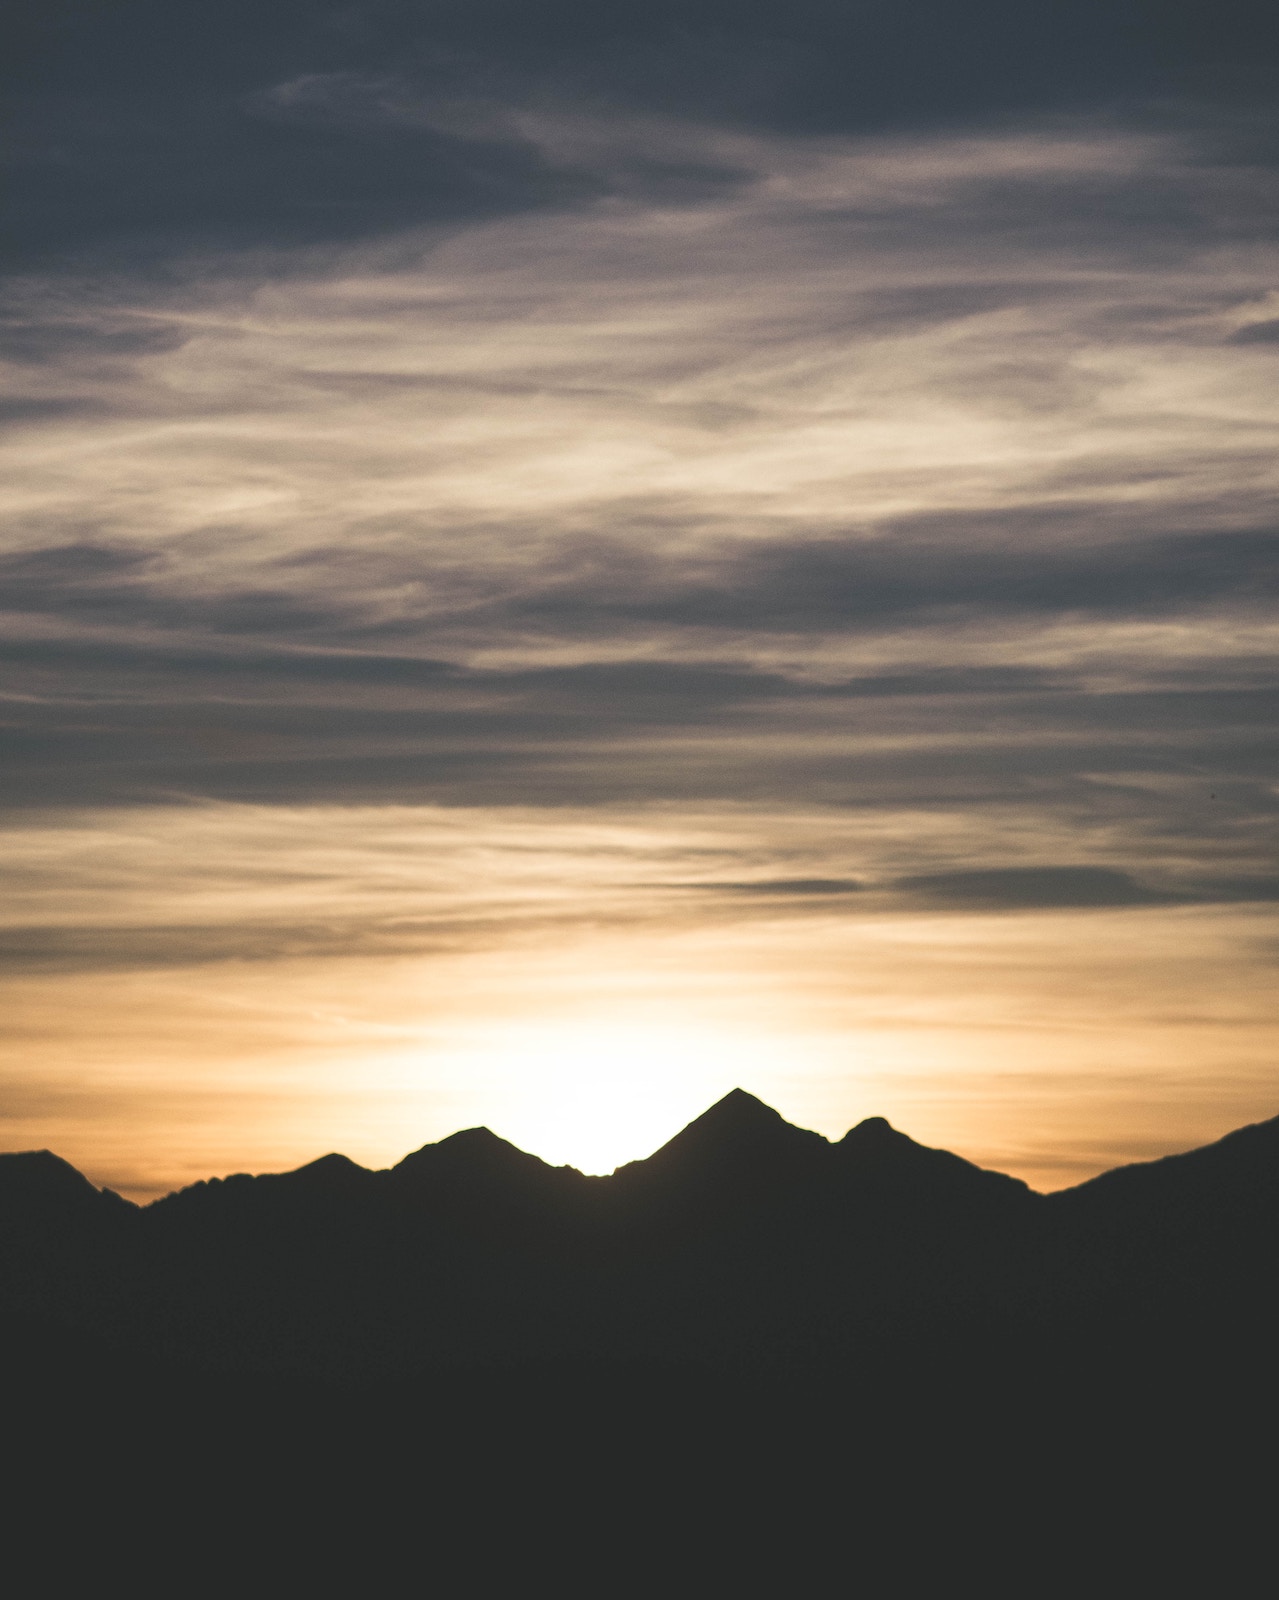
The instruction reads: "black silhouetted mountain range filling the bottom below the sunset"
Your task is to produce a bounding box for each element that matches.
[0,1091,1279,1594]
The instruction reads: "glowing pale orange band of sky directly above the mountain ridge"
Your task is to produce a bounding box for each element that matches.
[0,805,1279,1198]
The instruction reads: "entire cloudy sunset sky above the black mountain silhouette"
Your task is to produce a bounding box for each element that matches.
[0,0,1279,1198]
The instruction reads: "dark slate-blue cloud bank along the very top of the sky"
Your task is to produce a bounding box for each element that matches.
[3,0,1279,266]
